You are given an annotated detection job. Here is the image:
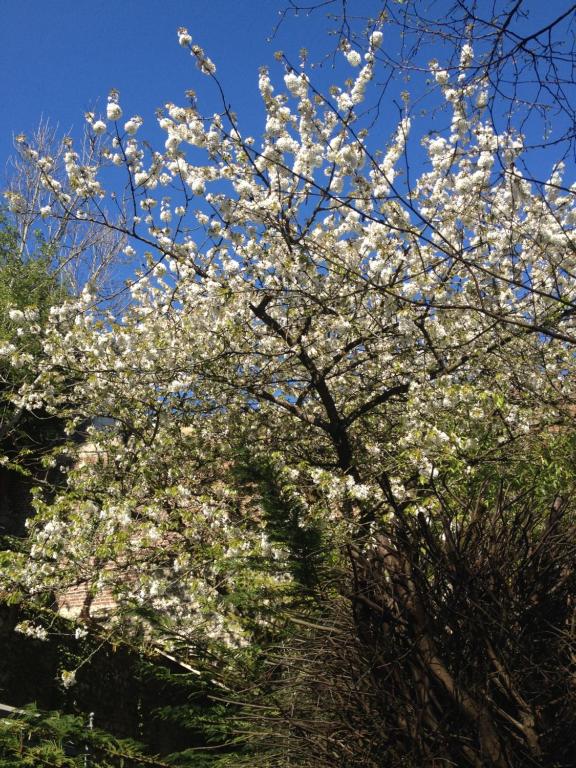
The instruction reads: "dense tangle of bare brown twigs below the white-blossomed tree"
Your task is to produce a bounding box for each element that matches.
[251,491,576,768]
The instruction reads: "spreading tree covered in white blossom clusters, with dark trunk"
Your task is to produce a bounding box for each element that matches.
[7,18,576,766]
